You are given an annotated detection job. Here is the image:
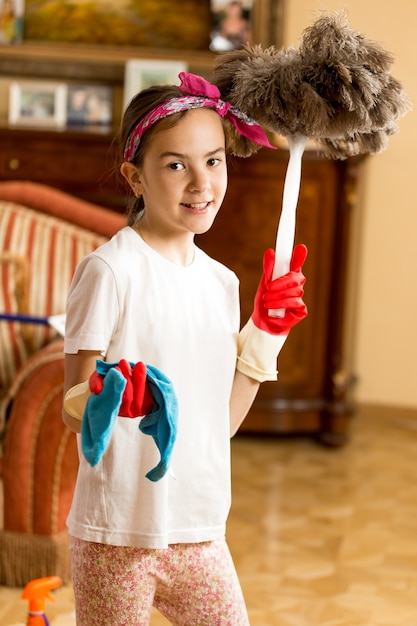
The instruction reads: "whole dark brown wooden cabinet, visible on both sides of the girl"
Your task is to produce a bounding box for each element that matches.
[0,128,361,445]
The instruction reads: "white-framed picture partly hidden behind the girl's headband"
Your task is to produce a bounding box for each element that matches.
[123,59,188,110]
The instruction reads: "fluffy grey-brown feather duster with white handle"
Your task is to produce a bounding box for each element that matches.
[213,12,410,314]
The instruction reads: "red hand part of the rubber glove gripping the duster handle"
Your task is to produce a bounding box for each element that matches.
[252,244,307,335]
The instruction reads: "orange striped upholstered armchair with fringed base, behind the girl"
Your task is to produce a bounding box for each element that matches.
[0,181,125,586]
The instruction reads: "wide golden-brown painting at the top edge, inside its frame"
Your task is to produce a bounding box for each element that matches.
[25,0,210,50]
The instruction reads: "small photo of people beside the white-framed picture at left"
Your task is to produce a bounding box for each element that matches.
[67,84,113,126]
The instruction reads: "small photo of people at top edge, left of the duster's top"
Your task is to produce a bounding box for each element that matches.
[210,0,253,52]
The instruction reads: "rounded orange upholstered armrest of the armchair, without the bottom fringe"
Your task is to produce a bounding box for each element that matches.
[3,340,78,535]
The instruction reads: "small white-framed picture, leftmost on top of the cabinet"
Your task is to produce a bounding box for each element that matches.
[9,81,67,128]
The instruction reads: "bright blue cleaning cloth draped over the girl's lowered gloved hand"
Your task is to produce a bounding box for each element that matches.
[81,359,178,482]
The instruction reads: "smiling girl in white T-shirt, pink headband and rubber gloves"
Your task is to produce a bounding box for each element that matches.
[63,74,307,626]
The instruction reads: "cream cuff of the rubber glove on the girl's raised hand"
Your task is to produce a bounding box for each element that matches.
[236,319,287,383]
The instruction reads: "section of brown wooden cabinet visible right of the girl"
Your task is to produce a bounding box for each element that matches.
[199,149,361,445]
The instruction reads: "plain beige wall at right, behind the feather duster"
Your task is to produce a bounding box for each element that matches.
[286,0,417,408]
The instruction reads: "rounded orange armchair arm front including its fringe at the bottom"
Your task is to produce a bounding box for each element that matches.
[0,340,78,587]
